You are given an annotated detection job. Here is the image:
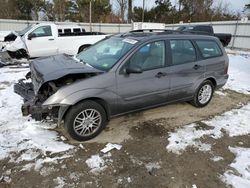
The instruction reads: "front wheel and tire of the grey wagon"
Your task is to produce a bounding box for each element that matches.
[64,100,107,141]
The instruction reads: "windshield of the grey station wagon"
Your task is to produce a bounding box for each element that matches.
[76,37,137,71]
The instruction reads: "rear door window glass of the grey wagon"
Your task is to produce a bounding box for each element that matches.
[170,40,196,65]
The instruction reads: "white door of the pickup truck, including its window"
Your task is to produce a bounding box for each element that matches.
[25,25,58,57]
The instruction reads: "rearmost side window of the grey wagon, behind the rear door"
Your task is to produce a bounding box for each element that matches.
[196,40,222,58]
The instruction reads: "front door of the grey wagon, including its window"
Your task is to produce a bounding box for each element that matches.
[117,41,170,113]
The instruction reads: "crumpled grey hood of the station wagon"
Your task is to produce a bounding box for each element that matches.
[30,54,103,94]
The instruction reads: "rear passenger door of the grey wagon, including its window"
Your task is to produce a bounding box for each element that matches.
[169,39,206,100]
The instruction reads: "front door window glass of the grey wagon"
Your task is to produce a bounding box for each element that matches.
[127,41,165,71]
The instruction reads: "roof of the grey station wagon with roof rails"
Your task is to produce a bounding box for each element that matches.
[114,30,220,42]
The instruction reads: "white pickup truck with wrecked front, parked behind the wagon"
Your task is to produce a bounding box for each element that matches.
[2,23,107,59]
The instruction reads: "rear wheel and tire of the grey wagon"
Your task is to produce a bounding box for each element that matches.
[191,80,214,107]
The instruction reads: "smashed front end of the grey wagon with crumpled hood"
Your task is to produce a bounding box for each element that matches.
[14,55,103,122]
